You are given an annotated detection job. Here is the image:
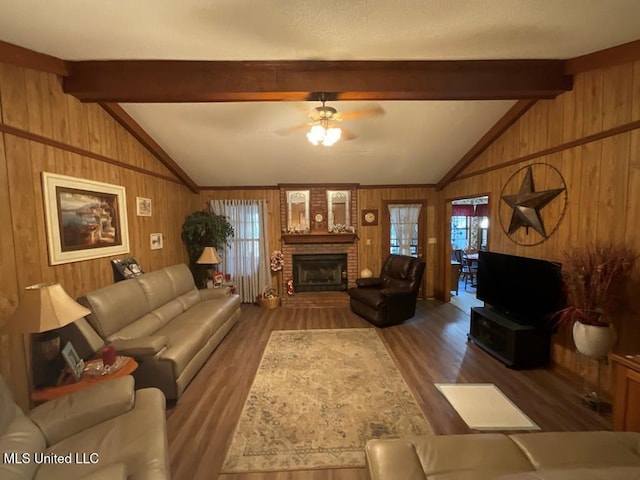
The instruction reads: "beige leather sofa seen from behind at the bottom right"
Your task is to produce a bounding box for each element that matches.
[366,432,640,480]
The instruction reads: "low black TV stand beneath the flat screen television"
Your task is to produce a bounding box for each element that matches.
[468,307,551,368]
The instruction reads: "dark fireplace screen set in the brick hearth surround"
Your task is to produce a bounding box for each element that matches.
[293,254,348,292]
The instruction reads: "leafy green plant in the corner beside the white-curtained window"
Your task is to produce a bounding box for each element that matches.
[180,210,234,284]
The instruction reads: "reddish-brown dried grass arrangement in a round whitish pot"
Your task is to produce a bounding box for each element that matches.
[556,242,638,358]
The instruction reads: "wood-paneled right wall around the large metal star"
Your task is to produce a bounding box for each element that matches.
[440,61,640,388]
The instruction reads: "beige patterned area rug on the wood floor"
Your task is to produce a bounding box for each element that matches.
[222,328,433,473]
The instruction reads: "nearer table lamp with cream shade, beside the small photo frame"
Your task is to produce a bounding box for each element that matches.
[0,283,91,387]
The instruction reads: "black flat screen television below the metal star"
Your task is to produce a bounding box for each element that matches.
[476,252,566,326]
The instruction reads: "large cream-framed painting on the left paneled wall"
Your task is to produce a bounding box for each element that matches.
[42,172,129,265]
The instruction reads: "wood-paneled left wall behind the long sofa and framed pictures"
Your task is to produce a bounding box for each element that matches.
[0,64,198,408]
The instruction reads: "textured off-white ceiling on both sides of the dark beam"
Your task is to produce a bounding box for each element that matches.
[0,0,640,186]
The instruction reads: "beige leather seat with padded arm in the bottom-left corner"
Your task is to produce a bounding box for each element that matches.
[0,376,170,480]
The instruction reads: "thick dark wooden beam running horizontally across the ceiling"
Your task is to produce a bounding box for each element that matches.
[63,60,572,103]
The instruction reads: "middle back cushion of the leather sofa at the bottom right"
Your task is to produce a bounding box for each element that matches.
[414,433,533,480]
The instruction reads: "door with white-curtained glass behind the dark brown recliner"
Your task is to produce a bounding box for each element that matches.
[381,199,427,298]
